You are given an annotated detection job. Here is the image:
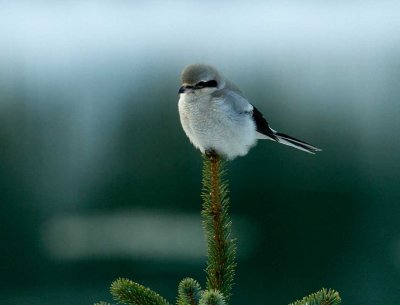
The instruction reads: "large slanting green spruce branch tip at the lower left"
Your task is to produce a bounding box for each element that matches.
[110,278,169,305]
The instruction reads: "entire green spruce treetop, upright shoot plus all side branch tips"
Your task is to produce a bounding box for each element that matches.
[95,152,341,305]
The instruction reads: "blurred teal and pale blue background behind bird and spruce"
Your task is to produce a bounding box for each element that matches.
[0,0,400,305]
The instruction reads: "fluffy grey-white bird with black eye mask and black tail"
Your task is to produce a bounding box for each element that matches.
[178,64,321,160]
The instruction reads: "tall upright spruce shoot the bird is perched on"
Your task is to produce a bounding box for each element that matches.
[202,153,236,301]
